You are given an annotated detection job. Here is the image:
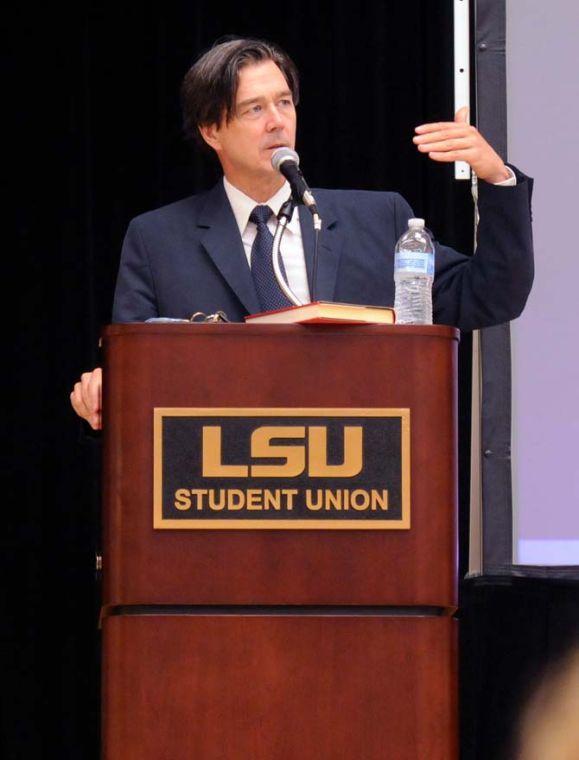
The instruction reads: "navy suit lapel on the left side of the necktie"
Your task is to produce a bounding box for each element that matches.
[198,181,260,314]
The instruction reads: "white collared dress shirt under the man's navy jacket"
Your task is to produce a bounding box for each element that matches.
[223,177,310,303]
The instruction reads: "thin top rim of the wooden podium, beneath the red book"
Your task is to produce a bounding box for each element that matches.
[102,322,460,341]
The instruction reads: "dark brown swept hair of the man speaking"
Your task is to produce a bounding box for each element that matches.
[181,39,299,145]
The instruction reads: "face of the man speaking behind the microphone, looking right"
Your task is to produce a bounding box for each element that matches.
[201,60,296,192]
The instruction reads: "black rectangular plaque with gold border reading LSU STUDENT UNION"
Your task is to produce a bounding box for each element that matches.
[154,408,410,530]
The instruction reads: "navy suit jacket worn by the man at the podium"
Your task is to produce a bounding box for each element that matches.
[113,172,533,330]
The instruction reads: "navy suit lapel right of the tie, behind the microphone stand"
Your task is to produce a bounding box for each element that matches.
[299,199,341,301]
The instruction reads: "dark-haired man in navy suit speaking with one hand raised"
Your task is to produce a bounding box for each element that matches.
[71,40,533,428]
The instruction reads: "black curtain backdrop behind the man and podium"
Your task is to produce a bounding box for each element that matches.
[5,0,579,760]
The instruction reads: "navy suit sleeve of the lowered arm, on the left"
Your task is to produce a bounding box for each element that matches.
[112,219,159,322]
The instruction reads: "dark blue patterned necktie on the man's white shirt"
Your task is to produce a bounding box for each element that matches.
[249,206,292,311]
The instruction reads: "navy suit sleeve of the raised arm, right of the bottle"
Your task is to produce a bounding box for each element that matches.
[397,167,534,330]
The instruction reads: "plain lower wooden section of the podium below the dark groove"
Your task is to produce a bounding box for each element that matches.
[103,615,458,760]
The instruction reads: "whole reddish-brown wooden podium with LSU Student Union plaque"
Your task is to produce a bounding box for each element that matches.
[102,324,458,760]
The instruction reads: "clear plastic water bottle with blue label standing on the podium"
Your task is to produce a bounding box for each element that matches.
[394,219,434,325]
